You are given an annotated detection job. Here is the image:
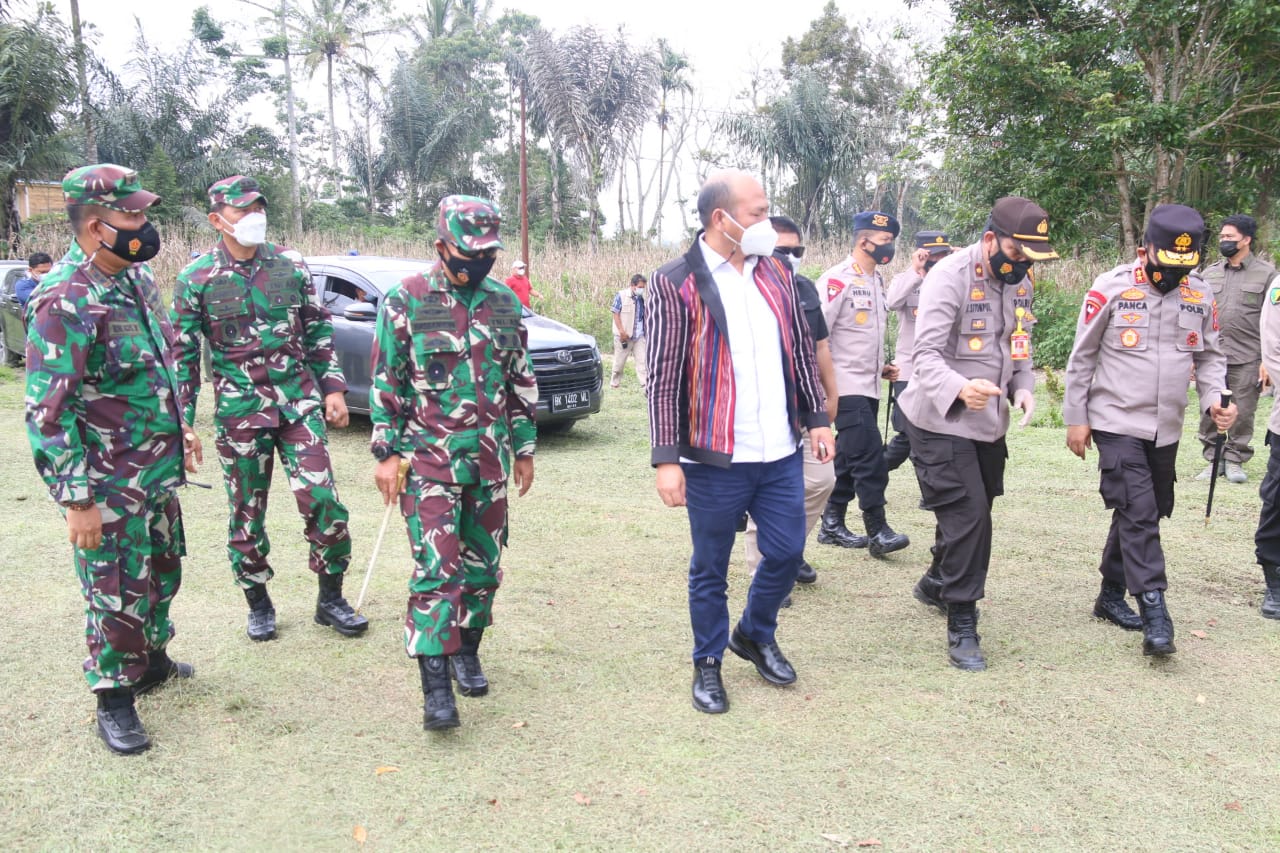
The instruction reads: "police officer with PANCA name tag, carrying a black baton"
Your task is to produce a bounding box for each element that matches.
[1062,205,1235,654]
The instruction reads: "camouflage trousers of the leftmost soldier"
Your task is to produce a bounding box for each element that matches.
[73,492,187,690]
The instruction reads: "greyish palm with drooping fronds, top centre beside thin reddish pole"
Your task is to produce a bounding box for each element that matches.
[517,27,658,248]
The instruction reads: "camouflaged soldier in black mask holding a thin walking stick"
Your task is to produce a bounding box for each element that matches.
[370,196,538,730]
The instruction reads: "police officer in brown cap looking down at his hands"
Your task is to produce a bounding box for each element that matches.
[899,196,1057,670]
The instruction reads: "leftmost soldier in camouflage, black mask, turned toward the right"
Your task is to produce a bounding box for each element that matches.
[27,164,200,754]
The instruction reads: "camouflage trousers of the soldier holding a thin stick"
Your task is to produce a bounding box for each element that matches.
[401,474,507,657]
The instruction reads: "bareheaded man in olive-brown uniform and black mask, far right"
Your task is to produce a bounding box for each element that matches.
[1196,214,1276,483]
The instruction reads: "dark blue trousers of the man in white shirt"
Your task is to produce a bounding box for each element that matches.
[682,451,804,661]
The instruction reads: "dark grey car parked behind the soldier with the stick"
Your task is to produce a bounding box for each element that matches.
[306,255,604,430]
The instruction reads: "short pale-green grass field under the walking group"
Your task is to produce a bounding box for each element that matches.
[0,361,1280,850]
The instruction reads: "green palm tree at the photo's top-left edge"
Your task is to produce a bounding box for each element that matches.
[0,4,77,252]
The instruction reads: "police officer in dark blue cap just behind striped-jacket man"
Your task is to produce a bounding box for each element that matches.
[818,210,910,557]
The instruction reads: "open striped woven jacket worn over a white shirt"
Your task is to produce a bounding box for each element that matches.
[645,234,831,467]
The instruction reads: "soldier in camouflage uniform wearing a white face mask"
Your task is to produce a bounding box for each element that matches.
[173,175,369,640]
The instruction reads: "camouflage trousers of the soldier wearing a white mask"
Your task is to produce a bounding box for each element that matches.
[216,410,351,589]
